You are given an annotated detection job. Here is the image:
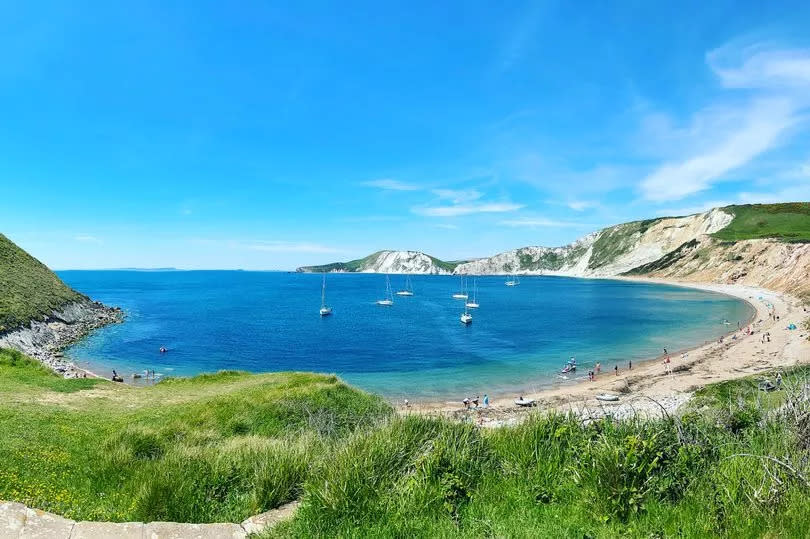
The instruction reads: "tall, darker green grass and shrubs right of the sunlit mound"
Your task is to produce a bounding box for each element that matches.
[265,364,810,538]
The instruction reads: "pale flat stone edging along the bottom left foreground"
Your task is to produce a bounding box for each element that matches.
[0,502,298,539]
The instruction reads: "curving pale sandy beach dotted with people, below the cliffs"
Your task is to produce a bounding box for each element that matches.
[397,278,810,426]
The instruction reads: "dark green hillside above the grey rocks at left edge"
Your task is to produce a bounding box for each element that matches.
[0,234,84,331]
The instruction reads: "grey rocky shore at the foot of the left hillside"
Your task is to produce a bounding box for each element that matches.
[0,300,124,378]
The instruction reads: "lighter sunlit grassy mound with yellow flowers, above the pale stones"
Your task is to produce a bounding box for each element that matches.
[0,350,390,522]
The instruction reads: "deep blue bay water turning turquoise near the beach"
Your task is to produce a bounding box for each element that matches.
[59,271,753,399]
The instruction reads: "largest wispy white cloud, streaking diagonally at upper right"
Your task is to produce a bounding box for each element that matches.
[640,43,810,202]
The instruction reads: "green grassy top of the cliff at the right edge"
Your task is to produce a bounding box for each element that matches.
[714,202,810,241]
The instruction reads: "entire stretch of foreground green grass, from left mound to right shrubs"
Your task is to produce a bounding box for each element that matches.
[0,352,810,538]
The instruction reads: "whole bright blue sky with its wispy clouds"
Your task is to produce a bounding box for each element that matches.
[0,0,810,269]
